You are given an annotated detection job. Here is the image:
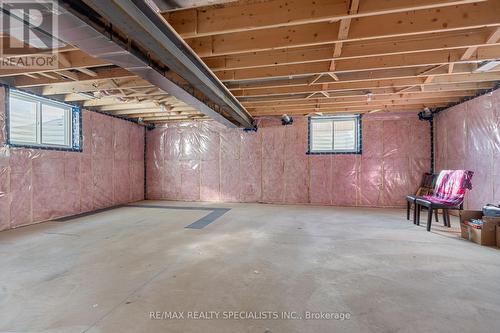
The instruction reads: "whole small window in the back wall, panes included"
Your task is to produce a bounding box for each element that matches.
[308,115,361,154]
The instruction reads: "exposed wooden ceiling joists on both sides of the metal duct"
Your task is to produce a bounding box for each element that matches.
[0,0,500,123]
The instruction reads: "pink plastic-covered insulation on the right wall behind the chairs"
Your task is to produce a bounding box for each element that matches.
[435,89,500,209]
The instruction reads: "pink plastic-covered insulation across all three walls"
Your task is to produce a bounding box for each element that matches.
[0,81,500,230]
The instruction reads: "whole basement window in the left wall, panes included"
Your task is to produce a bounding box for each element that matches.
[6,89,81,151]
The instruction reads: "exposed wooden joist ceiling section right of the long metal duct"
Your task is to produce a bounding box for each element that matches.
[163,0,500,115]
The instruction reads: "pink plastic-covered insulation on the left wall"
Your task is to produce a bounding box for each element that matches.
[0,88,144,230]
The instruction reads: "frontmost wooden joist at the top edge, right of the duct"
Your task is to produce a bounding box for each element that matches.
[164,0,486,38]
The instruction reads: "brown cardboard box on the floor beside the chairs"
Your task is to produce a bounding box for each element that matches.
[460,210,500,246]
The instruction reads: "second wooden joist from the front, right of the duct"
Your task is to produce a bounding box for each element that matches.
[188,1,500,57]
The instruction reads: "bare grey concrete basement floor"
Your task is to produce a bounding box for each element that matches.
[0,202,500,333]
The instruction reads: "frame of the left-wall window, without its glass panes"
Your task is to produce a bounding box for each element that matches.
[5,86,83,152]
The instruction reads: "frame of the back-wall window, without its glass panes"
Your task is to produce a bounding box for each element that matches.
[307,114,362,155]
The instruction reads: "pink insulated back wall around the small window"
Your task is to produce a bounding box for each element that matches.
[146,112,430,207]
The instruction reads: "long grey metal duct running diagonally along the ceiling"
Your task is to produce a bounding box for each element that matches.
[1,0,254,128]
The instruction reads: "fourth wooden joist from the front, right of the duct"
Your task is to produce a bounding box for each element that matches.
[215,45,500,81]
